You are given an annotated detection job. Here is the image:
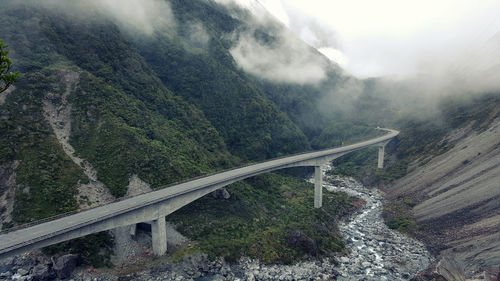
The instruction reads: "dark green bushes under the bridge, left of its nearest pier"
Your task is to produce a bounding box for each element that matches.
[42,231,114,267]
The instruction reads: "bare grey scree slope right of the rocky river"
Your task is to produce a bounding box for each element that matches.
[388,118,500,275]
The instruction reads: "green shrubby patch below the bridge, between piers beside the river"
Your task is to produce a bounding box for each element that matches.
[169,174,354,263]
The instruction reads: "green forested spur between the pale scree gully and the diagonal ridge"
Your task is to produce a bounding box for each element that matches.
[32,10,233,196]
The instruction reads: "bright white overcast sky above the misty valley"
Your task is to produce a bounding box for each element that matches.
[259,0,500,77]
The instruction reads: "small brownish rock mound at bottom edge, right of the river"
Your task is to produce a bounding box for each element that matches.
[411,258,466,281]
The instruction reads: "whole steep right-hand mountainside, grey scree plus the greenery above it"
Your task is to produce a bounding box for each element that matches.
[378,93,500,276]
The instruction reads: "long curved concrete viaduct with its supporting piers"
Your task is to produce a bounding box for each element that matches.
[0,129,399,258]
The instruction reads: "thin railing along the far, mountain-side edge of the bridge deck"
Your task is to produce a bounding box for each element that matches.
[0,129,398,235]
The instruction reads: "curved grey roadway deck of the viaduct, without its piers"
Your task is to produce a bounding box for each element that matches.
[0,129,399,258]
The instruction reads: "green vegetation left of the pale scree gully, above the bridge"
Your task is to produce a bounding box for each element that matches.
[0,70,87,223]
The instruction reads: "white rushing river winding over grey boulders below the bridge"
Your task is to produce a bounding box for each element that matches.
[323,166,432,280]
